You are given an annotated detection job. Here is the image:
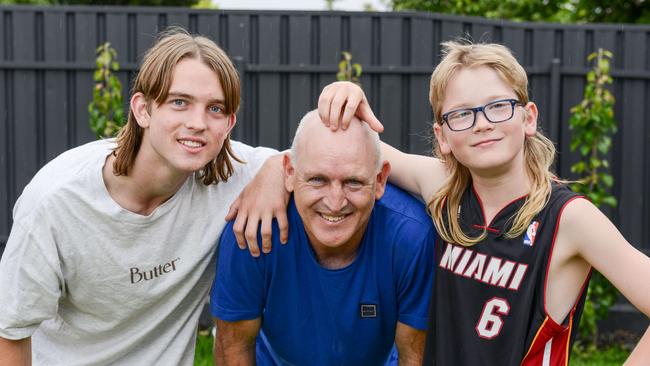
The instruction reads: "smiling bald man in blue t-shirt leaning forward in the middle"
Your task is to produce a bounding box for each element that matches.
[211,111,436,365]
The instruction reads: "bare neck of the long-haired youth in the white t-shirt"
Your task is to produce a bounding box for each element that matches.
[102,154,190,216]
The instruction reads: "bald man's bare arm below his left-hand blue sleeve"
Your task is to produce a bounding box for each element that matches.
[214,318,262,366]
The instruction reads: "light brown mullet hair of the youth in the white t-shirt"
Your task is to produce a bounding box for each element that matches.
[113,27,242,185]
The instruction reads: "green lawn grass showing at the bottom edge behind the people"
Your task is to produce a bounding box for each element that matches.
[194,334,630,366]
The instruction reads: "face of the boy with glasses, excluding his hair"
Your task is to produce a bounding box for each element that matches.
[434,66,537,175]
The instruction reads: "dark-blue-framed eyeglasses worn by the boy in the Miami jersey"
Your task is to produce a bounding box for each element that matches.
[442,99,522,131]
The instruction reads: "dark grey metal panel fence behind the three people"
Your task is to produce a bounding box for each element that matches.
[0,6,650,264]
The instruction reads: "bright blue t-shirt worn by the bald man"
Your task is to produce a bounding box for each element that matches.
[210,185,436,365]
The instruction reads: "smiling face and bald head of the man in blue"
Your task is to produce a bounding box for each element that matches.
[284,113,390,255]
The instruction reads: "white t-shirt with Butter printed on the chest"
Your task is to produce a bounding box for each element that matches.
[0,140,275,366]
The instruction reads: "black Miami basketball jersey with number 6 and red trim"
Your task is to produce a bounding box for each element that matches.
[424,184,588,366]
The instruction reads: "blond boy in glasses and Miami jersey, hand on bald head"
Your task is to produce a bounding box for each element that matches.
[319,42,650,365]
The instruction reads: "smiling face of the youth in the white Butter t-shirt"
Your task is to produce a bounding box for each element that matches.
[131,58,235,175]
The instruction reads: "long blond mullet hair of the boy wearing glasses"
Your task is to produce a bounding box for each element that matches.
[428,41,556,246]
